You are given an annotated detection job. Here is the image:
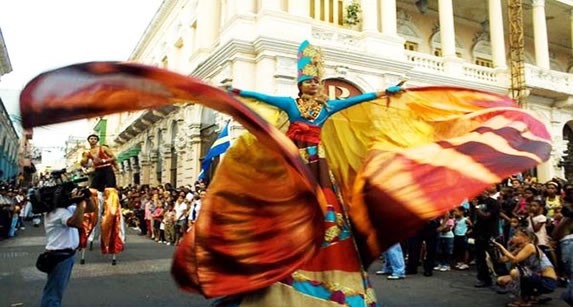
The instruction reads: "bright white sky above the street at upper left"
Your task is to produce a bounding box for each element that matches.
[0,0,162,147]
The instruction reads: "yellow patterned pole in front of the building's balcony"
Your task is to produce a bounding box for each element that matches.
[507,0,526,106]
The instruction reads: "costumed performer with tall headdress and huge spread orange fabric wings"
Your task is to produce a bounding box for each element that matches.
[20,42,551,307]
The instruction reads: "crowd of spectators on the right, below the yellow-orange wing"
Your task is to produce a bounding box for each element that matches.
[376,175,573,306]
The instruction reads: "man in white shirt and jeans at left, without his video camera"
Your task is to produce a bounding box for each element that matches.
[41,189,94,307]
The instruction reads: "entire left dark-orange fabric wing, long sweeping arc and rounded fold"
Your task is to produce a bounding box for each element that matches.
[20,62,326,296]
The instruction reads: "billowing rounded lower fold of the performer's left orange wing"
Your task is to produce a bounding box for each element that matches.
[172,134,324,297]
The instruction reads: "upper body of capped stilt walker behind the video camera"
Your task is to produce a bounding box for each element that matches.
[81,134,117,192]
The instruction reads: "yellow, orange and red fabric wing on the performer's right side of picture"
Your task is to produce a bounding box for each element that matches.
[323,87,551,266]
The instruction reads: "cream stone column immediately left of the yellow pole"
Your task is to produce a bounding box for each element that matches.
[488,0,507,69]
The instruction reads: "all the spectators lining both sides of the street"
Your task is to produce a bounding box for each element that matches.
[4,172,573,306]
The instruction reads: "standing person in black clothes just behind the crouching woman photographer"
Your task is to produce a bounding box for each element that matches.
[472,186,508,288]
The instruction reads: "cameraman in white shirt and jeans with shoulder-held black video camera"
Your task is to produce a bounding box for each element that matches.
[32,173,95,307]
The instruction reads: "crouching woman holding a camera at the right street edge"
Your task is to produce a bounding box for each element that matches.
[493,229,557,306]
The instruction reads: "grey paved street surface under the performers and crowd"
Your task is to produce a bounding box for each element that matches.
[0,222,566,307]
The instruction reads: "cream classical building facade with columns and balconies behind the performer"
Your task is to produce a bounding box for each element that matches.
[98,0,573,186]
